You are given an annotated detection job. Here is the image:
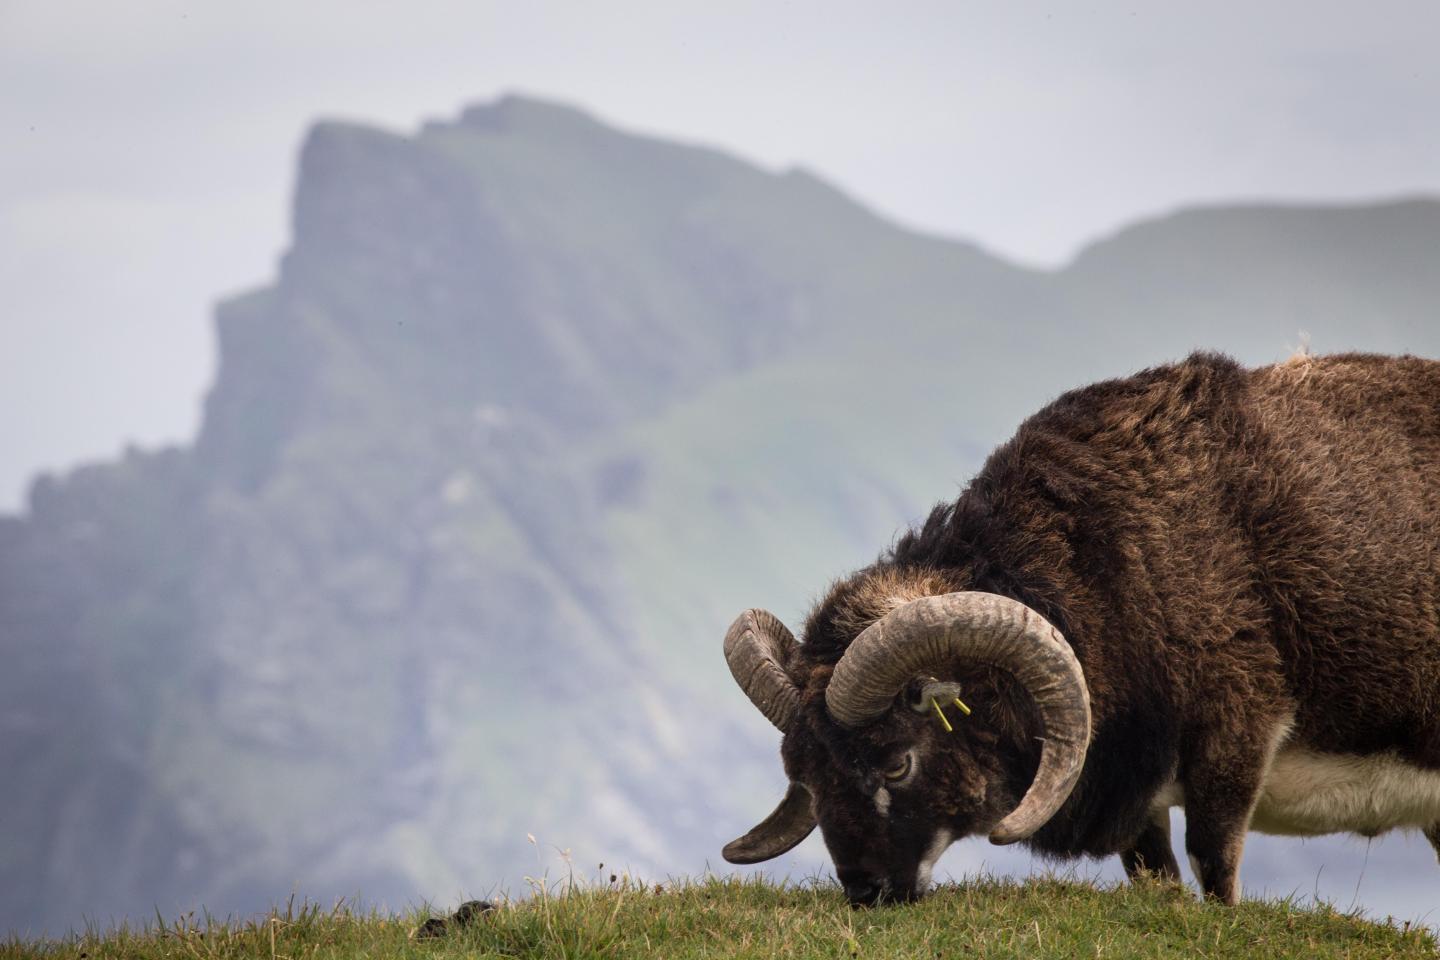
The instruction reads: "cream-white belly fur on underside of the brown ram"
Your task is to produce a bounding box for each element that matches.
[1152,747,1440,836]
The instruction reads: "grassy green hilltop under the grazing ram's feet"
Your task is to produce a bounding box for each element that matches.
[0,879,1437,960]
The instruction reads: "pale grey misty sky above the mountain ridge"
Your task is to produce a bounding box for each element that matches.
[0,0,1440,510]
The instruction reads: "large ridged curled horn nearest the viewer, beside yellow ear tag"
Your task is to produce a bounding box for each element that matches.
[825,593,1090,843]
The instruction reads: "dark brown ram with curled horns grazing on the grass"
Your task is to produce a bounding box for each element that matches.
[724,354,1440,904]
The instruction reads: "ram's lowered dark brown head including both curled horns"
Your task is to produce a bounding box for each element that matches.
[724,566,1090,904]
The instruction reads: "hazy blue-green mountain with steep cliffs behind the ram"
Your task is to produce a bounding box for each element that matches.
[0,98,1440,933]
